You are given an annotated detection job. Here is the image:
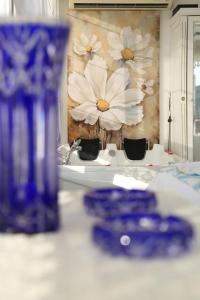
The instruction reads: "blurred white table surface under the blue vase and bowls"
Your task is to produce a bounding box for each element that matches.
[0,191,200,300]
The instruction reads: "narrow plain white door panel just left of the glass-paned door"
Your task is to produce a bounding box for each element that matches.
[170,16,188,159]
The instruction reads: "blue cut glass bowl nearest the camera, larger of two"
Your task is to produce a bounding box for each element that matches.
[92,213,194,258]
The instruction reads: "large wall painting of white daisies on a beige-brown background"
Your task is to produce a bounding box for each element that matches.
[67,10,159,148]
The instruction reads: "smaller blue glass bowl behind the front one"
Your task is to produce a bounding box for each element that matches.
[84,188,157,218]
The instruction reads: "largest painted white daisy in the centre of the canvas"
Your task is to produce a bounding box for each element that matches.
[68,55,144,130]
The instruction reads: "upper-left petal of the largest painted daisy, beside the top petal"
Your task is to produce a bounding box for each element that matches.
[68,72,96,103]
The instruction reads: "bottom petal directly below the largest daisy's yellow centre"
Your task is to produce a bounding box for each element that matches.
[99,110,122,130]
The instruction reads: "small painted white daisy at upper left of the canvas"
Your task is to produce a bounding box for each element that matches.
[73,33,101,55]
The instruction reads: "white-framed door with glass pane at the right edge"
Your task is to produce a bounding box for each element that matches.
[187,16,200,161]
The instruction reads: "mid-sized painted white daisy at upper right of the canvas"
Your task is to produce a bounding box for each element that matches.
[108,26,153,74]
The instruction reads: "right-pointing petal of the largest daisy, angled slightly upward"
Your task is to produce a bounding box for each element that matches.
[110,89,144,108]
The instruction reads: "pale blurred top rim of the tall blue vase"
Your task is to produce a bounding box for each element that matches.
[0,16,71,27]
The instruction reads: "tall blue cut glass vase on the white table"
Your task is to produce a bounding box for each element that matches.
[0,20,69,234]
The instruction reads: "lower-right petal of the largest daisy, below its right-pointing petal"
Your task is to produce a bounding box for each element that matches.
[111,106,144,126]
